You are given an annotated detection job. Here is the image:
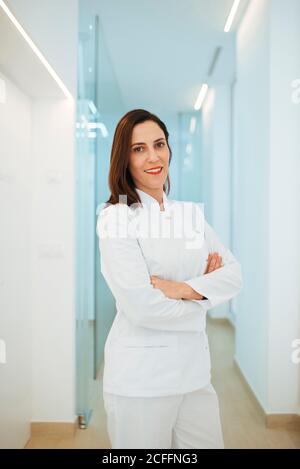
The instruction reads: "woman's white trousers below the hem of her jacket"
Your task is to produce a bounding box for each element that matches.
[103,384,224,449]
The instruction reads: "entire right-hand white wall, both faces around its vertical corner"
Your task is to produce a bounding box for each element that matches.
[233,0,300,413]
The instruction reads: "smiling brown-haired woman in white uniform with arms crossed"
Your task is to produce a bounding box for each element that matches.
[97,109,242,449]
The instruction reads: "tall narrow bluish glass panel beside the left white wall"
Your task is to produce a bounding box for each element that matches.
[76,2,98,428]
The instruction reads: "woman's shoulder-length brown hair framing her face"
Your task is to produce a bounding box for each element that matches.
[106,109,172,205]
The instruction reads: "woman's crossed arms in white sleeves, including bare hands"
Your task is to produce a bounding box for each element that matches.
[97,205,241,331]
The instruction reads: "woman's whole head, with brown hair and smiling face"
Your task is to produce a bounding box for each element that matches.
[107,109,172,205]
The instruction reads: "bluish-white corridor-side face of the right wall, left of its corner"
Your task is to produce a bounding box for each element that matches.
[233,0,270,407]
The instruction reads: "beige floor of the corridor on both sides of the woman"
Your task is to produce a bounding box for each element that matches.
[26,320,300,448]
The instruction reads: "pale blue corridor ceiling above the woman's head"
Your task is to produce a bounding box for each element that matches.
[90,0,250,112]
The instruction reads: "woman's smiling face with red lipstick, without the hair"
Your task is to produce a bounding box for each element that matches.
[129,120,170,194]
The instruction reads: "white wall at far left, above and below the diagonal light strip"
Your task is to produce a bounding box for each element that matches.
[0,0,78,448]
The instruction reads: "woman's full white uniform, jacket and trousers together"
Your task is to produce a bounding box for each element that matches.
[97,189,242,448]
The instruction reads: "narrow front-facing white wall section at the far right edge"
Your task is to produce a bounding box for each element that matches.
[268,0,300,413]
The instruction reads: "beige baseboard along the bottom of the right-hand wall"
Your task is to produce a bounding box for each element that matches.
[233,358,300,431]
